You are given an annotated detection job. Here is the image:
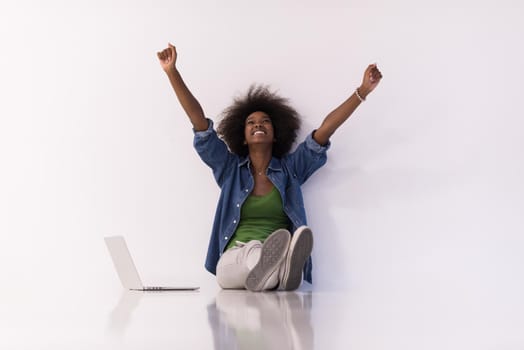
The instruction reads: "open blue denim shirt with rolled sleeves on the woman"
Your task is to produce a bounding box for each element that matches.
[193,119,330,283]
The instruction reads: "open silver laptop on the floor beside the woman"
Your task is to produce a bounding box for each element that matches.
[104,236,200,291]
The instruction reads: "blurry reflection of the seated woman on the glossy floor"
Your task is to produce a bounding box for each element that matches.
[208,290,314,350]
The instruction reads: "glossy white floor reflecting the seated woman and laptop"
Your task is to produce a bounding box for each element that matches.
[4,276,524,350]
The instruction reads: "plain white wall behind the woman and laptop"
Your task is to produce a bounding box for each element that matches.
[0,0,524,348]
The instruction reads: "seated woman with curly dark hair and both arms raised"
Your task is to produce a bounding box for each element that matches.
[157,44,382,291]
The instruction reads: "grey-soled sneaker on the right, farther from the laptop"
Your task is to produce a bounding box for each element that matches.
[279,228,313,291]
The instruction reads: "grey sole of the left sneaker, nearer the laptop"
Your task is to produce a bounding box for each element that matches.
[245,230,291,292]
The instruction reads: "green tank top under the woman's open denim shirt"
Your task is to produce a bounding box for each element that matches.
[226,187,289,249]
